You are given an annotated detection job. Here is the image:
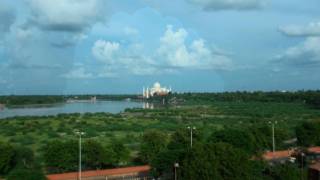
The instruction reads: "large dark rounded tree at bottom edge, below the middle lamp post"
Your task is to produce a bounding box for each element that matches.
[180,143,252,180]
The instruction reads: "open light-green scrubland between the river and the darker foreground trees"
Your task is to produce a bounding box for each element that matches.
[0,102,320,162]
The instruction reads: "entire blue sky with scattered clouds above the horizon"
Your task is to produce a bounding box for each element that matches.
[0,0,320,94]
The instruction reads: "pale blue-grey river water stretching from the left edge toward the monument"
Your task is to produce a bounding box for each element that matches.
[0,101,143,118]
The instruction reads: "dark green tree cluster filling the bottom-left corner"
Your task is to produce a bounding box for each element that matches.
[0,142,46,180]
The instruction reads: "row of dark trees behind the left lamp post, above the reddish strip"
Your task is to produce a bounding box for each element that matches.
[43,140,130,173]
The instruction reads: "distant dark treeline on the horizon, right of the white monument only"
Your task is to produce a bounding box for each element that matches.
[171,90,320,107]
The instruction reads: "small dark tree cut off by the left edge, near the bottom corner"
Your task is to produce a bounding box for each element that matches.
[0,142,15,175]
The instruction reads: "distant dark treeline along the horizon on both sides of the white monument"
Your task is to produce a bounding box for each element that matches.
[0,90,320,108]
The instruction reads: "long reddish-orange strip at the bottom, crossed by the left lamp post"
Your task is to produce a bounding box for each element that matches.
[47,165,151,180]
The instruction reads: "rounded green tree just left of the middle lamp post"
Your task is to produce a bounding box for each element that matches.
[139,130,168,163]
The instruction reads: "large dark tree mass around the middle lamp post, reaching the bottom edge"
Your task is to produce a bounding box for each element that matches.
[140,127,300,179]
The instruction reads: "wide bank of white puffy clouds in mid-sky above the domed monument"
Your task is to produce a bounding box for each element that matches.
[92,25,233,76]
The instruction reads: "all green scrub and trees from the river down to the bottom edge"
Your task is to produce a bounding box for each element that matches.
[0,91,320,179]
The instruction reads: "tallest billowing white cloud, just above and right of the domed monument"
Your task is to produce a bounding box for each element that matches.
[157,26,232,69]
